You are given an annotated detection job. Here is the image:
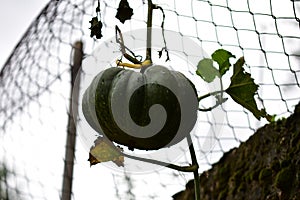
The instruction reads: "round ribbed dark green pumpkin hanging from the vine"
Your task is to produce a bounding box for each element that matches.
[82,65,198,150]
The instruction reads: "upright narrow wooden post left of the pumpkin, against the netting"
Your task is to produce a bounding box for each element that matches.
[61,41,83,200]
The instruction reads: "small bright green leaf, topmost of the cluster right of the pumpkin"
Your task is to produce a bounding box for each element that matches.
[211,49,235,76]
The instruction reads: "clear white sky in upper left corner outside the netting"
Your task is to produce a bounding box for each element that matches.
[0,0,49,67]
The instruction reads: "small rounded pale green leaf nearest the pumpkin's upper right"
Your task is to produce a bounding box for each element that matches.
[196,58,219,83]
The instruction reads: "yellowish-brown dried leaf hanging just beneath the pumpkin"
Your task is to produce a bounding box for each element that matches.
[88,137,124,167]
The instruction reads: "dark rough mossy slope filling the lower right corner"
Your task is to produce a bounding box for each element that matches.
[173,104,300,200]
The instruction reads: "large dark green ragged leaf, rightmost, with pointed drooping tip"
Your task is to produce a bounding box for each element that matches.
[226,57,272,121]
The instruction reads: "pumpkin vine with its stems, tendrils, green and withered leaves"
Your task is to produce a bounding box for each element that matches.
[85,0,274,200]
